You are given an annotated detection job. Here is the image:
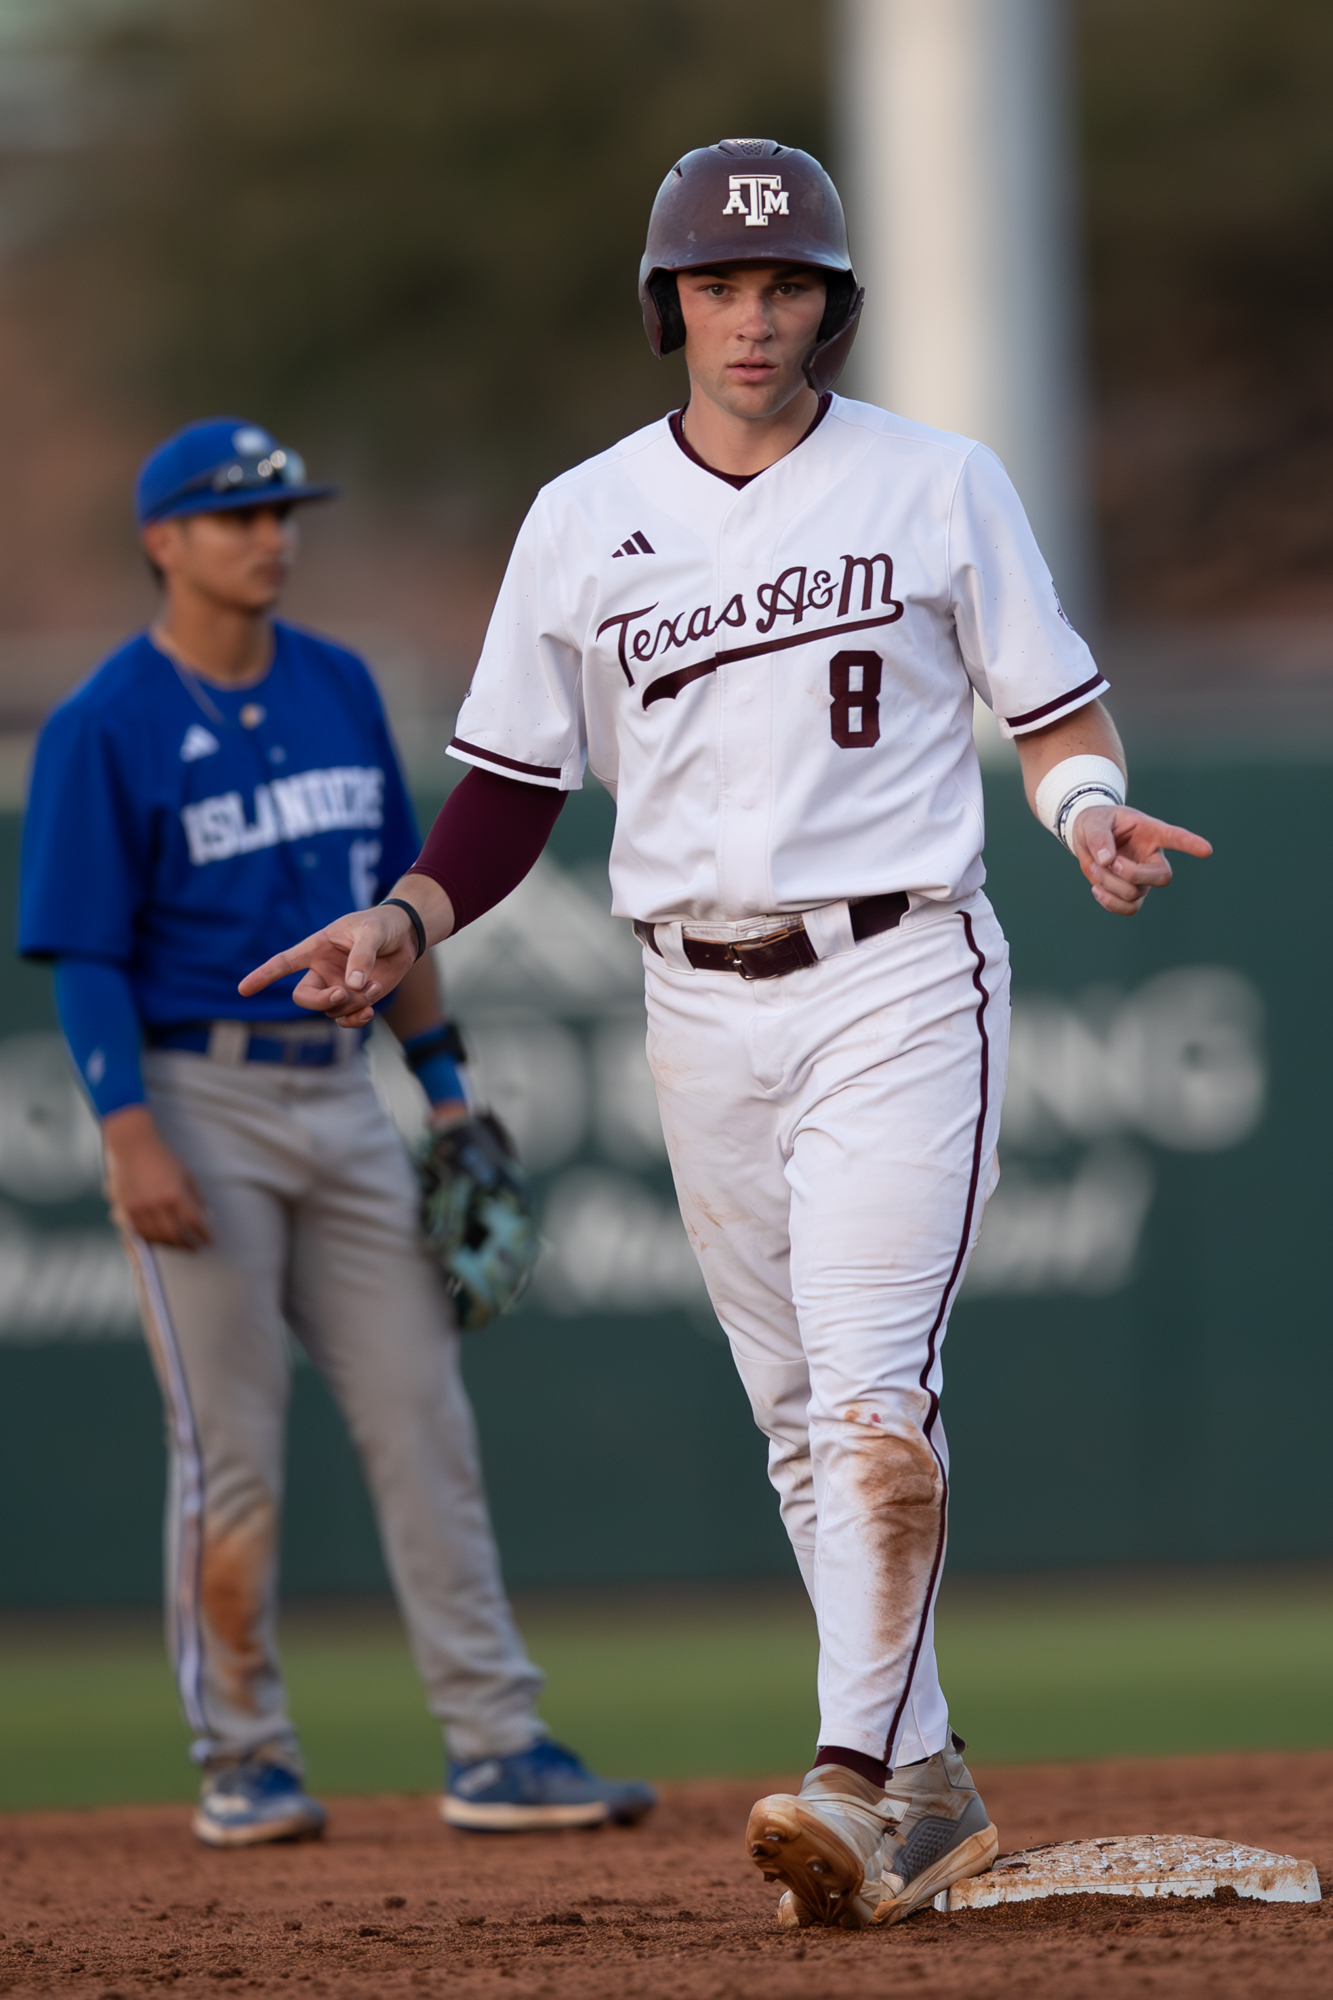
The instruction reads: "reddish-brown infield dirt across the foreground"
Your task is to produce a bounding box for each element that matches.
[0,1752,1333,2000]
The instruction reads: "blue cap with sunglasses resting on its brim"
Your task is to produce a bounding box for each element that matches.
[134,416,338,528]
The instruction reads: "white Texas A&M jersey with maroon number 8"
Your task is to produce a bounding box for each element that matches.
[450,396,1107,922]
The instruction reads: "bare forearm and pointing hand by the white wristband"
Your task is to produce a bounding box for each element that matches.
[1015,702,1213,916]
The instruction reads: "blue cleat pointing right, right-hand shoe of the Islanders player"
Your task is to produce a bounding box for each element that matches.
[440,1742,656,1834]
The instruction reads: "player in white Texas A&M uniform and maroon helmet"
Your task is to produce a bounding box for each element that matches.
[242,140,1209,1926]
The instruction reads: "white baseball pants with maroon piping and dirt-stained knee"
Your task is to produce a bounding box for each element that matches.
[644,894,1009,1764]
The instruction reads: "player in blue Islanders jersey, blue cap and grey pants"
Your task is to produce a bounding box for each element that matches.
[20,418,652,1846]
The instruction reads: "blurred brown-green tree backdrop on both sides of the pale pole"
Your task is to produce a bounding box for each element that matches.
[0,0,1333,650]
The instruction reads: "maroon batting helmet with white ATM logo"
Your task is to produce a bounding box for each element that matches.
[638,138,865,394]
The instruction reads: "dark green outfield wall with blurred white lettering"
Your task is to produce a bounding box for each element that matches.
[0,756,1333,1604]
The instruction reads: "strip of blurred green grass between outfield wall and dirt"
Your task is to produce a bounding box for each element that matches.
[0,1572,1333,1810]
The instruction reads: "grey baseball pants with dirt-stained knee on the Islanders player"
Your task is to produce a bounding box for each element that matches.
[130,1050,546,1764]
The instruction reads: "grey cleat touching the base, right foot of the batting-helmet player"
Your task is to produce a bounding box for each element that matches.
[871,1732,999,1924]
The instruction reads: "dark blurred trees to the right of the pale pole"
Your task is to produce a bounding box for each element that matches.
[1079,0,1333,620]
